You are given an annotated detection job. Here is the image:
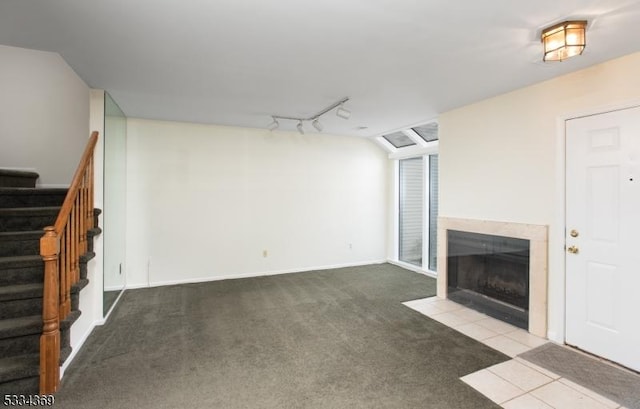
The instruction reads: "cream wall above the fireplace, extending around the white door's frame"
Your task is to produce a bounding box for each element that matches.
[439,53,640,342]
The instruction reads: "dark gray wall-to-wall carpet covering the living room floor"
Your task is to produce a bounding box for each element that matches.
[56,264,508,409]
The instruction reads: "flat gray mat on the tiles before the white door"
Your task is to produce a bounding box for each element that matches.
[520,343,640,409]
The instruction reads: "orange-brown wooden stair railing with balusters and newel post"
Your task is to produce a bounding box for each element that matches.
[40,131,98,395]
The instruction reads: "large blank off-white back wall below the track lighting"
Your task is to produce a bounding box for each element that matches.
[126,118,389,287]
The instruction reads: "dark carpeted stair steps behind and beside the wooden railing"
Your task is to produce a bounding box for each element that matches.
[0,169,100,395]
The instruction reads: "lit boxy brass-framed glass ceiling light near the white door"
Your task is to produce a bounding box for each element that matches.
[541,20,587,61]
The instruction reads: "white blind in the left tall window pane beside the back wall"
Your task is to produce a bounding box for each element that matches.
[398,157,424,267]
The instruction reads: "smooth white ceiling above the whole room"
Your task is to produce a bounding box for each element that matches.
[0,0,640,136]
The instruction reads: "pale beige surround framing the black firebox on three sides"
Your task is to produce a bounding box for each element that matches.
[438,217,548,338]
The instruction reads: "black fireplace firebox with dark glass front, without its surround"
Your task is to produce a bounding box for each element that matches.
[447,230,529,329]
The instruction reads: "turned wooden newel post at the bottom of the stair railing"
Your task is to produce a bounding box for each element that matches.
[40,226,60,395]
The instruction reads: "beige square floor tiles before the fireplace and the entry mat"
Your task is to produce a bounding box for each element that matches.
[404,297,625,409]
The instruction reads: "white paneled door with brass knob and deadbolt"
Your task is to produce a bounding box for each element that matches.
[565,107,640,370]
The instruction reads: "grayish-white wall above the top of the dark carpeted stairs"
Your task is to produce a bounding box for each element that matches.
[0,45,89,186]
